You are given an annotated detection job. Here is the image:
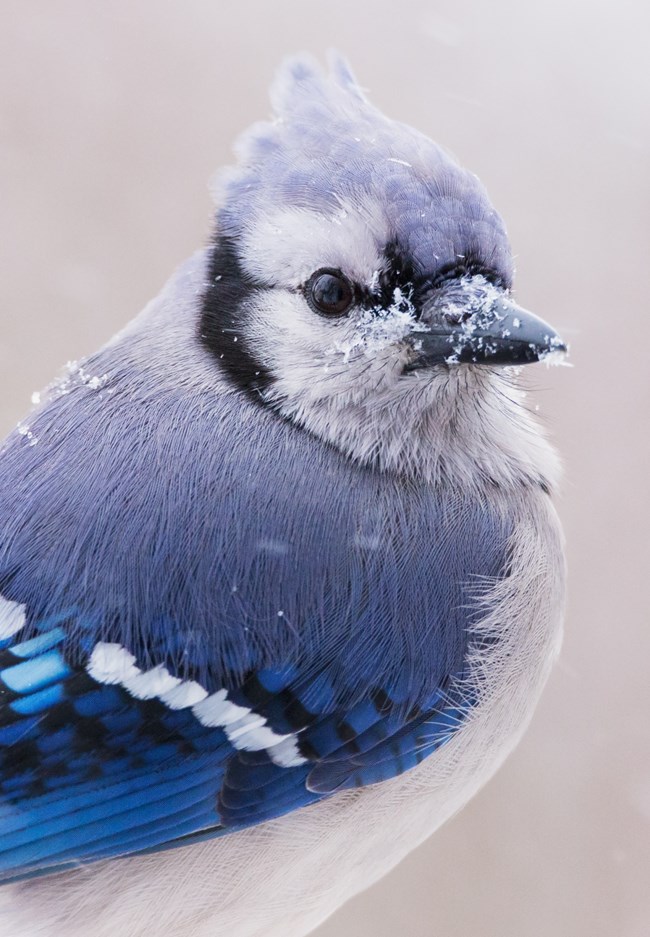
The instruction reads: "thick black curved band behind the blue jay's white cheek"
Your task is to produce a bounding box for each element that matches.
[199,237,271,403]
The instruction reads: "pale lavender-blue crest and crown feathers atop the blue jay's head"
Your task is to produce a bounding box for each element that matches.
[217,56,512,286]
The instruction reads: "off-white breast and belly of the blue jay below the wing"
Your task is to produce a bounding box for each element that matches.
[0,493,564,937]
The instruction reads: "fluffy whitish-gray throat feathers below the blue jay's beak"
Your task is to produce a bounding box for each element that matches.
[270,366,560,493]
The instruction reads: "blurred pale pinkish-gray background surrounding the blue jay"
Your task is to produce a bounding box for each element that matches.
[0,0,650,937]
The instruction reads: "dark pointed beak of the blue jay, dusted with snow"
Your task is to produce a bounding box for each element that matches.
[406,295,567,371]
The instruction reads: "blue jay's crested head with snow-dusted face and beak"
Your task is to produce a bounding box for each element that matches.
[200,58,565,490]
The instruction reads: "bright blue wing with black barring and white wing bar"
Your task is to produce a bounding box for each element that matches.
[0,600,470,881]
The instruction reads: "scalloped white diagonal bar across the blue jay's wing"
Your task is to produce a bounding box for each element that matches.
[87,642,306,768]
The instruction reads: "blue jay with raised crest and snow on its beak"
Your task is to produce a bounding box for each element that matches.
[0,54,567,937]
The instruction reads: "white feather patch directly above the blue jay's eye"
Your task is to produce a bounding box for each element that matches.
[240,207,388,288]
